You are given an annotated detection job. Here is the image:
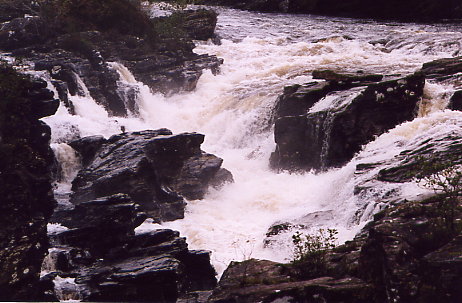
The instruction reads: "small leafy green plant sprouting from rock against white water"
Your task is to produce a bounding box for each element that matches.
[292,229,338,278]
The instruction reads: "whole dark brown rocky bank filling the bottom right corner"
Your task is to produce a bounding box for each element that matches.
[210,191,462,302]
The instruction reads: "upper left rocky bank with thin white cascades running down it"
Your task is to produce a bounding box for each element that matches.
[0,0,222,116]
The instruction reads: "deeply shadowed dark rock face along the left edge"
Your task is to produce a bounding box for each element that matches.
[0,64,59,301]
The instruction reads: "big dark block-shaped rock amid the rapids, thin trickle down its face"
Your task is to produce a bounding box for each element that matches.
[271,73,425,170]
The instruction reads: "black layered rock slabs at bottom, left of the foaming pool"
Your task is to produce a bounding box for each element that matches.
[48,194,216,302]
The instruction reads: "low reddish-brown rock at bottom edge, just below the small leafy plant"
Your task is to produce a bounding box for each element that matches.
[209,259,372,303]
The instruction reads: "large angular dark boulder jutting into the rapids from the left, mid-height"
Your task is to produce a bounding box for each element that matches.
[71,129,232,221]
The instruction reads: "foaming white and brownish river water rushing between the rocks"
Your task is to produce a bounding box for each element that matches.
[45,9,462,273]
